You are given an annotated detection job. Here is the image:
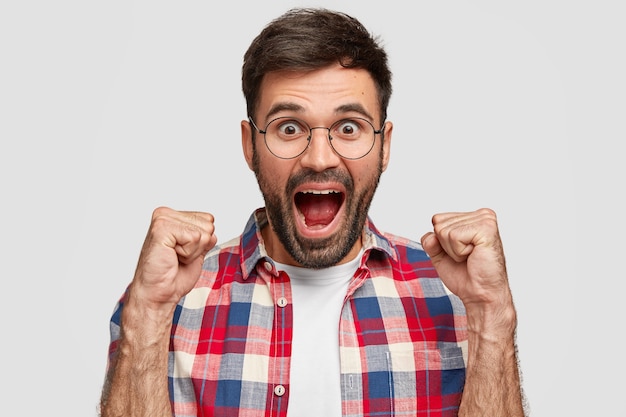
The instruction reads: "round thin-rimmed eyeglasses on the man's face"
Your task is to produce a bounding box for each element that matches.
[249,117,383,159]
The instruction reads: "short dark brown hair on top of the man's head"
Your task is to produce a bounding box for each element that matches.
[241,8,391,123]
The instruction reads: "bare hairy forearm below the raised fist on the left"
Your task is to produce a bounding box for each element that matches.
[101,297,172,417]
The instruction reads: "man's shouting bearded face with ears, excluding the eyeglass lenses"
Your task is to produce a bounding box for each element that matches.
[242,65,392,268]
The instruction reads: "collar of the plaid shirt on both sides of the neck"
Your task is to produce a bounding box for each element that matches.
[240,208,396,279]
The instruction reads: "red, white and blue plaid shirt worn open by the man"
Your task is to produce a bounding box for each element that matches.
[110,209,467,417]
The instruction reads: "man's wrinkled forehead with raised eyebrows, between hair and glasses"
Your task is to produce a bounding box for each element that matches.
[257,65,379,121]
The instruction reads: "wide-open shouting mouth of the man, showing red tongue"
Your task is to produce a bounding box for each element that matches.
[294,190,345,229]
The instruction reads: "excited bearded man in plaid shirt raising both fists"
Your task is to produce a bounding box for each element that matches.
[101,9,523,417]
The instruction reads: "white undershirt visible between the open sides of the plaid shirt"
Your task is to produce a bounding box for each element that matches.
[276,254,361,417]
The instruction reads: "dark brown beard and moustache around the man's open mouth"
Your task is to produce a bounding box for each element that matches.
[253,150,382,269]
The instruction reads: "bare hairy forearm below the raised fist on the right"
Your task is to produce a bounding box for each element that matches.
[459,304,525,417]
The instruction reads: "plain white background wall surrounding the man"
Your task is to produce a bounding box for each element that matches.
[0,0,626,417]
